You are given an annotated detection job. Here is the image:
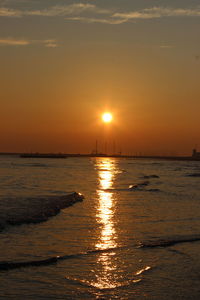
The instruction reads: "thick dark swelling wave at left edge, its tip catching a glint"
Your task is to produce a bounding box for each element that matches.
[0,192,84,230]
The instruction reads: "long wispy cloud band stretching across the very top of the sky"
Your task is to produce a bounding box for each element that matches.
[0,2,200,24]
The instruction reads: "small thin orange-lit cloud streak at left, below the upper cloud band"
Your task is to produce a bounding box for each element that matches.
[0,38,58,48]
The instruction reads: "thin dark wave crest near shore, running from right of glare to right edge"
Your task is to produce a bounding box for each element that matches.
[139,235,200,248]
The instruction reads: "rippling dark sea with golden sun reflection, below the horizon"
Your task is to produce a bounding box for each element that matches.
[0,156,200,300]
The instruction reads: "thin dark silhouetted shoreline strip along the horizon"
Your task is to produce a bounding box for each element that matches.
[0,152,200,161]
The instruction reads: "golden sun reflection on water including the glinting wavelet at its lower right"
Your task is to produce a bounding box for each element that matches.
[87,158,151,290]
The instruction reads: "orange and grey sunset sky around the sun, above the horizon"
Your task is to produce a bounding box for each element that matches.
[0,0,200,155]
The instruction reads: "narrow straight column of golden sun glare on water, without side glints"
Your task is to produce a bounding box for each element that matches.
[93,158,120,289]
